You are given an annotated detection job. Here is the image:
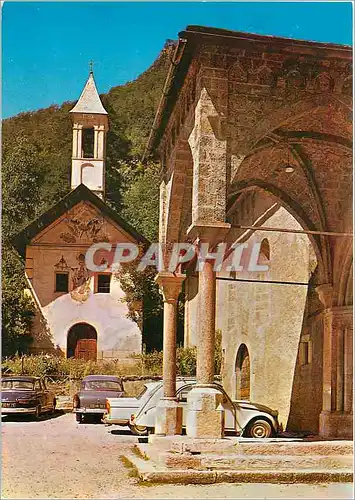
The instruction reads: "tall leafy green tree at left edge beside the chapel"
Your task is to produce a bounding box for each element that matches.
[2,137,46,355]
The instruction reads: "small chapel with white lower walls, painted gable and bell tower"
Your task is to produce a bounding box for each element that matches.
[14,71,147,360]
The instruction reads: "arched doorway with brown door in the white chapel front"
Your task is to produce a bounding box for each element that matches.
[67,323,97,361]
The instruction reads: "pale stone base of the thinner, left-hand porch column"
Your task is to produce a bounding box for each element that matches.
[155,398,182,436]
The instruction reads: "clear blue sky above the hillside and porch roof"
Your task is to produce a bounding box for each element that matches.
[2,2,352,118]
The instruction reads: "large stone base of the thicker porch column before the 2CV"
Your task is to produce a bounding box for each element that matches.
[186,386,225,438]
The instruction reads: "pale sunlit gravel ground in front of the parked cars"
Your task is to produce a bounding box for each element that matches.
[1,414,353,499]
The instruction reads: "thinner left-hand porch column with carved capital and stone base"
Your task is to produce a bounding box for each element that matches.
[155,272,185,436]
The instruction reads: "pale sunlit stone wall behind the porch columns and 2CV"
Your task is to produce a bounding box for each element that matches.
[185,208,322,430]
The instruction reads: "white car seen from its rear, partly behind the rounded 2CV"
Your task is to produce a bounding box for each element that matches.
[102,378,195,436]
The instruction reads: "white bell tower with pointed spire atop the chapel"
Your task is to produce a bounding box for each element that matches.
[70,68,108,199]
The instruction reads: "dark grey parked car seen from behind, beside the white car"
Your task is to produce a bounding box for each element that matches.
[73,375,124,423]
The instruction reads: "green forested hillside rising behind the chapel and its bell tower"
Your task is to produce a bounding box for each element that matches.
[2,42,172,356]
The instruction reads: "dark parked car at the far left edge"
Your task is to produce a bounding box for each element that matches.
[1,375,56,418]
